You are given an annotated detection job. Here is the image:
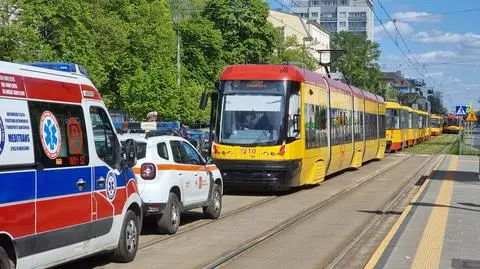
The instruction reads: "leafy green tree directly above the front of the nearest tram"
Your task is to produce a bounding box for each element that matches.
[203,0,279,64]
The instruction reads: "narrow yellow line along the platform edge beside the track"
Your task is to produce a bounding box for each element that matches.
[364,155,444,269]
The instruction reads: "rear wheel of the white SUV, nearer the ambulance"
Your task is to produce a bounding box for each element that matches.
[157,193,181,234]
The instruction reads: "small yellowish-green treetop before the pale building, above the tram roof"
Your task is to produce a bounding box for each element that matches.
[272,36,318,71]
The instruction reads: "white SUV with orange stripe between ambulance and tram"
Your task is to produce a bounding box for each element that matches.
[120,135,223,234]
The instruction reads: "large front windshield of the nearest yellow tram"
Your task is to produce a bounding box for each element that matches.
[218,81,290,146]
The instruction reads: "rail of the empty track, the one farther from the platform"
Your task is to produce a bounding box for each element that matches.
[200,155,413,269]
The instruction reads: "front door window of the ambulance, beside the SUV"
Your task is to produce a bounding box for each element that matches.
[90,107,120,167]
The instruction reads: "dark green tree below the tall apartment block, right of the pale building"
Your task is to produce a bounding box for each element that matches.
[331,31,386,96]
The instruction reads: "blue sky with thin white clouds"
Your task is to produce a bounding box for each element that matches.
[269,0,480,110]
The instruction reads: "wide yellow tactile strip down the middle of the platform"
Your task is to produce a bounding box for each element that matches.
[412,156,458,269]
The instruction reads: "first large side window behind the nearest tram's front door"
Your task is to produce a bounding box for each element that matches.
[305,104,327,148]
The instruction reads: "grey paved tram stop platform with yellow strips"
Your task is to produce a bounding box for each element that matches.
[365,155,480,269]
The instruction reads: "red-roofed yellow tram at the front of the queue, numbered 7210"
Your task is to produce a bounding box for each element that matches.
[208,64,386,191]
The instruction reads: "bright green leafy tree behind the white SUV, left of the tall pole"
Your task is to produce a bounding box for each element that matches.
[119,0,181,120]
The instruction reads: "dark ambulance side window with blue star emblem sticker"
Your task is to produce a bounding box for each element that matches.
[28,102,89,168]
